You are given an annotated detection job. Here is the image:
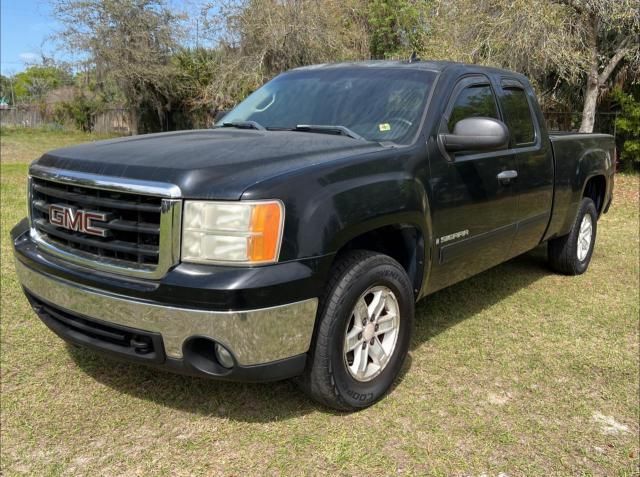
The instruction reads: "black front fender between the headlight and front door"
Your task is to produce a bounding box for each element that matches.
[243,144,431,290]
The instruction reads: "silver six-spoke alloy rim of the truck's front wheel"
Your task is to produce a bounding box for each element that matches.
[343,286,400,382]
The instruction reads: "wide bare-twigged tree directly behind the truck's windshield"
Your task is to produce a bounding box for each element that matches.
[202,0,369,108]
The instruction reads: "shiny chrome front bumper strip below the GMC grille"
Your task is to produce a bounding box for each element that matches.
[16,259,318,366]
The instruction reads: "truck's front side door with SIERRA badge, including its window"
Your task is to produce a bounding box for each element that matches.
[430,75,517,291]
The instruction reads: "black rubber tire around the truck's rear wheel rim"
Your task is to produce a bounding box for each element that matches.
[547,198,598,275]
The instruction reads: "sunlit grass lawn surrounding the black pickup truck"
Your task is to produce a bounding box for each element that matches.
[0,130,640,476]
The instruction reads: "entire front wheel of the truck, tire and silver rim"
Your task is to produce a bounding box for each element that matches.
[300,251,414,411]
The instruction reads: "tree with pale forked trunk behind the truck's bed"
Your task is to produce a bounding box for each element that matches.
[423,0,640,132]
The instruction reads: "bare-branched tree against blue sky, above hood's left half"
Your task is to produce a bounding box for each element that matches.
[53,0,181,134]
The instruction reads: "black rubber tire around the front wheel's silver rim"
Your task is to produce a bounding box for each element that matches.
[298,251,415,411]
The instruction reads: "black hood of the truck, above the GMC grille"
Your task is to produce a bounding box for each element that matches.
[35,128,382,200]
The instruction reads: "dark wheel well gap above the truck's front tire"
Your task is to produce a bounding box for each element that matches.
[336,224,424,295]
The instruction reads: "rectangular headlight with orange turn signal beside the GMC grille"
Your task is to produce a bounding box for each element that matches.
[182,200,284,265]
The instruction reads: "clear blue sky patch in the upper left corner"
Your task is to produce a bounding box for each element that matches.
[0,0,63,75]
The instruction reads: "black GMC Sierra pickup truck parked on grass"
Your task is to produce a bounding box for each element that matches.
[12,61,615,410]
